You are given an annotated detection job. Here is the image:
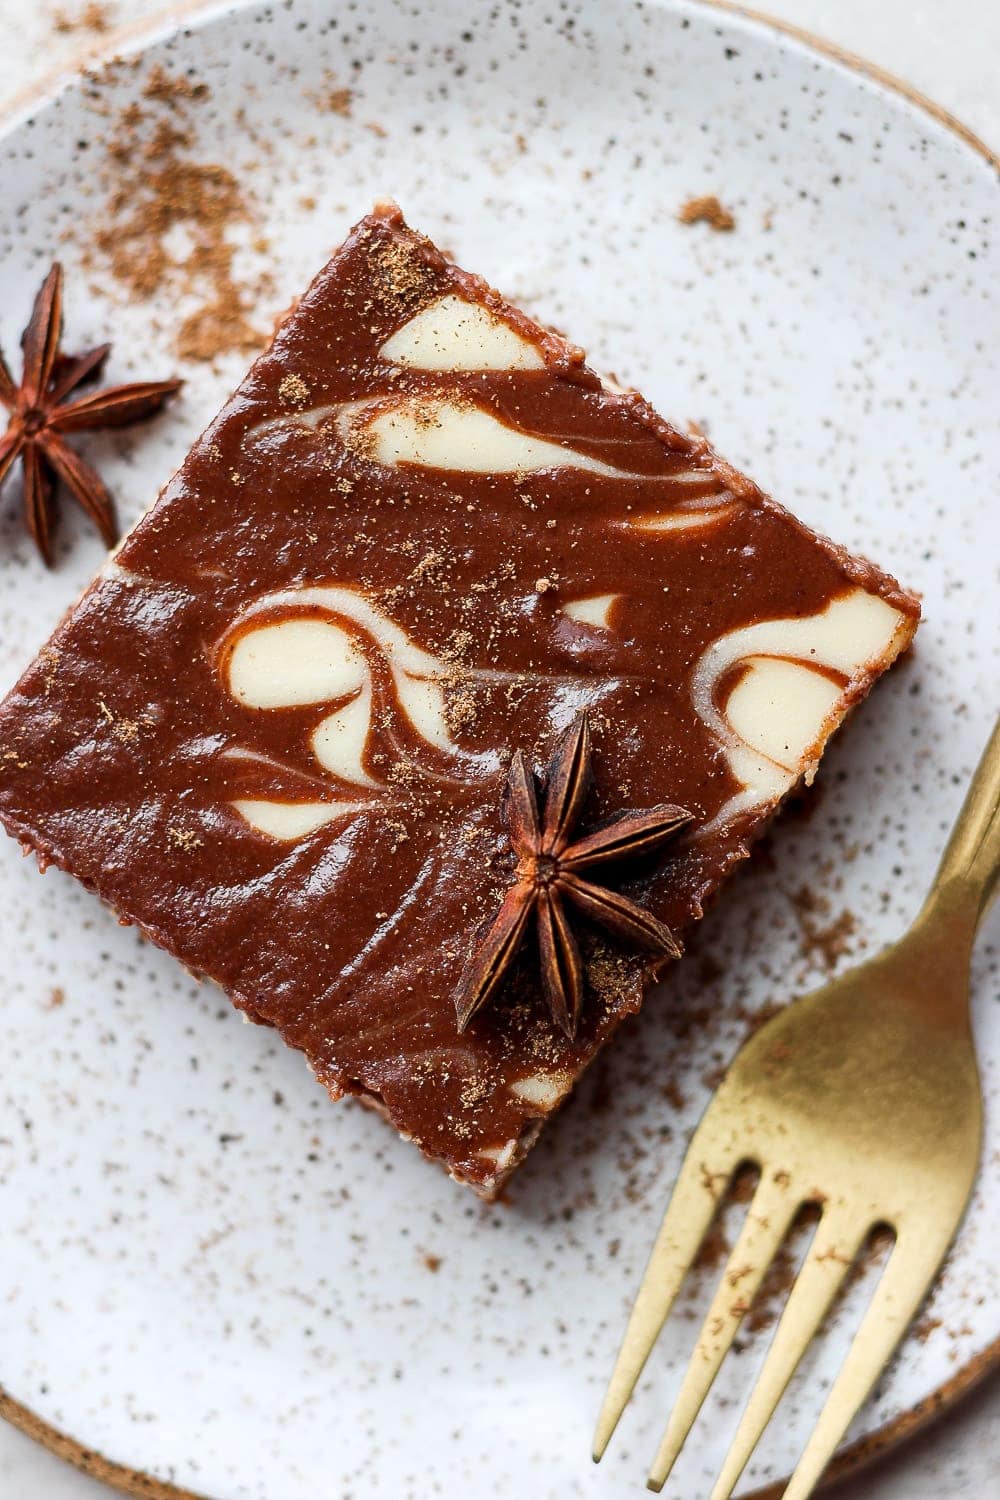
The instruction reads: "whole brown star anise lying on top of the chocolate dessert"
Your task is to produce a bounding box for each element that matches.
[456,714,691,1040]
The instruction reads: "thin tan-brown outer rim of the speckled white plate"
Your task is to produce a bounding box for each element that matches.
[0,0,1000,1500]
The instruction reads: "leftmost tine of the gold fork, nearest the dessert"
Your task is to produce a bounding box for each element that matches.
[594,1116,742,1463]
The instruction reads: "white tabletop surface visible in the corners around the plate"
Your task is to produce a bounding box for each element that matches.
[0,0,1000,1500]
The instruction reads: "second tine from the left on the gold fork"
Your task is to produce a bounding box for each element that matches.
[648,1169,801,1490]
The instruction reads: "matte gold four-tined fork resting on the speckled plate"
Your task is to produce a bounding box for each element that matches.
[594,722,1000,1500]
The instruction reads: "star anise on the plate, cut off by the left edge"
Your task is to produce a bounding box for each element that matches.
[0,264,183,566]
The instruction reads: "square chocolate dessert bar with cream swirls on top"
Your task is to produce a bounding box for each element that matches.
[0,204,919,1197]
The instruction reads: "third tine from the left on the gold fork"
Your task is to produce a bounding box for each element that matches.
[711,1208,868,1500]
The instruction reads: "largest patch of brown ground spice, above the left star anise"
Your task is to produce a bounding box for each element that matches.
[83,68,270,360]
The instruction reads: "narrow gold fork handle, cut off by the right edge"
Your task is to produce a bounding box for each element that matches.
[925,719,1000,936]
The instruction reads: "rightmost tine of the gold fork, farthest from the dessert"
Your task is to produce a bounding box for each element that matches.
[783,1223,955,1500]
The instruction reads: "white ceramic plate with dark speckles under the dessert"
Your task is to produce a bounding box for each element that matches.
[0,0,1000,1500]
